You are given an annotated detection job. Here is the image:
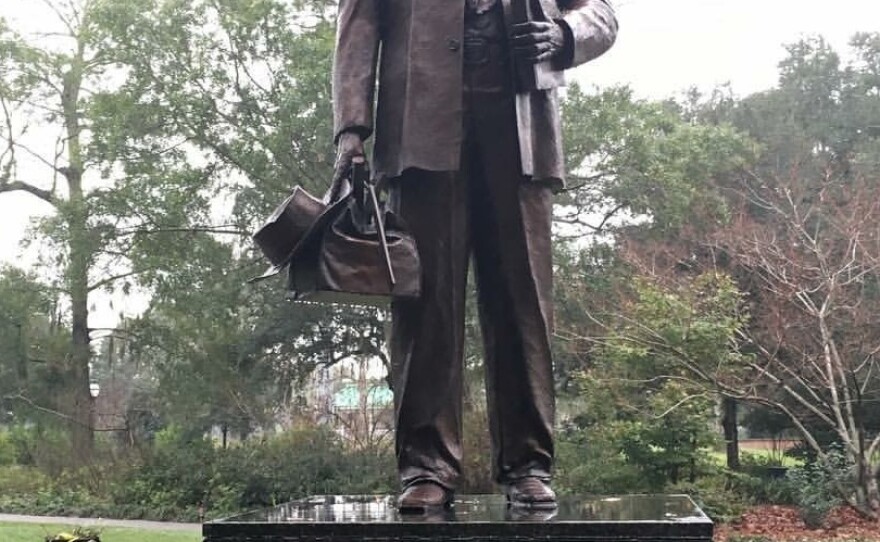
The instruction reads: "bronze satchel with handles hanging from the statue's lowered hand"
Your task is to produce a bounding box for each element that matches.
[288,168,421,306]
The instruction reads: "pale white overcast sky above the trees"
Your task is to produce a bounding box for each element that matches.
[0,0,880,324]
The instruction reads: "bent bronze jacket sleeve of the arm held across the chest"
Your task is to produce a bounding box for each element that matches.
[559,0,617,68]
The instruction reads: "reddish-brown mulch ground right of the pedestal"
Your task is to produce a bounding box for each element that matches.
[715,506,880,542]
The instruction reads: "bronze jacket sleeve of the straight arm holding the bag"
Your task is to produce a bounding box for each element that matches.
[333,0,382,141]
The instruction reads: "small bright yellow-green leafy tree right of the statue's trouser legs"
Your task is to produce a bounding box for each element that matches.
[560,274,745,491]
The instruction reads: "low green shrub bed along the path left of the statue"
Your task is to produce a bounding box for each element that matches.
[0,427,396,521]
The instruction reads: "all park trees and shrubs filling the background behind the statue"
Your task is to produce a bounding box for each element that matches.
[0,0,880,522]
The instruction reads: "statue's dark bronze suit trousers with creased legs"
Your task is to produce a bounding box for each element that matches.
[390,76,555,489]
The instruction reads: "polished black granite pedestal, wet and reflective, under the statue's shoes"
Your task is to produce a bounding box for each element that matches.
[203,495,712,542]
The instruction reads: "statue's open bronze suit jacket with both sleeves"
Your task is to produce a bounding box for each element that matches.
[333,0,617,186]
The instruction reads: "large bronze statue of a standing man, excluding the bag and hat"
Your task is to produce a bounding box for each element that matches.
[333,0,617,511]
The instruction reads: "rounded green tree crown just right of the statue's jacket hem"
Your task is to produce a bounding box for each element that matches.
[556,85,755,236]
